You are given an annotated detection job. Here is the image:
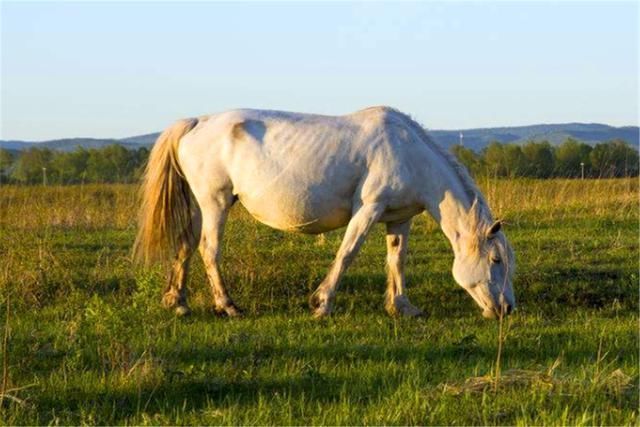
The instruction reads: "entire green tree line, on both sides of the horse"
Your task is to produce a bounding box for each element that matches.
[0,138,639,184]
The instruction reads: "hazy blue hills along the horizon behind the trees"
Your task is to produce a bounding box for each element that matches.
[0,123,640,151]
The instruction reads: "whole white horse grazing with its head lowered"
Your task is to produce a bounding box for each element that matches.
[135,107,515,318]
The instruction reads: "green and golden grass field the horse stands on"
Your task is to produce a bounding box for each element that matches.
[0,179,640,425]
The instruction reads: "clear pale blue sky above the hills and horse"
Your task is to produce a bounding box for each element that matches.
[0,2,639,140]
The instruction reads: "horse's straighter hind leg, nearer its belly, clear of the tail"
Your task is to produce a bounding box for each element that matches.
[200,193,242,317]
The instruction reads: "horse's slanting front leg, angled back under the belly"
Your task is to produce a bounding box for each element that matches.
[309,203,384,317]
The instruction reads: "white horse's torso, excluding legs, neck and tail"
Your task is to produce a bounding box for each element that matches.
[181,108,424,233]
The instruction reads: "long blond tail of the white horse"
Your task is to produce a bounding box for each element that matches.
[133,119,198,265]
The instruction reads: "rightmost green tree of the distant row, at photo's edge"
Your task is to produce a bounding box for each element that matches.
[589,139,639,178]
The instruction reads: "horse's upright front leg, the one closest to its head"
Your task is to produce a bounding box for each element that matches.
[385,220,423,317]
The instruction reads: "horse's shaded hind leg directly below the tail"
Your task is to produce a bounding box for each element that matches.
[162,211,201,316]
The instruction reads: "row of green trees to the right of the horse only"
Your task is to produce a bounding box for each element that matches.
[451,138,639,178]
